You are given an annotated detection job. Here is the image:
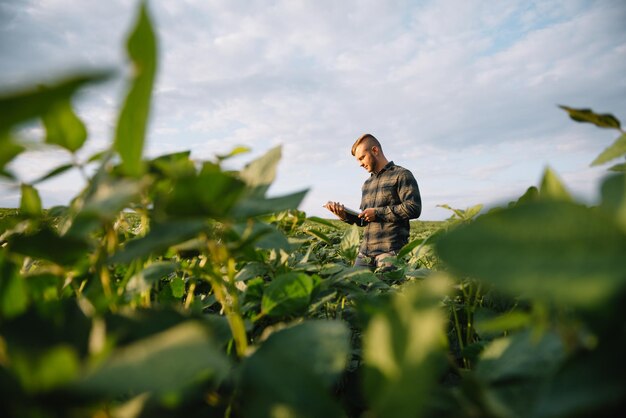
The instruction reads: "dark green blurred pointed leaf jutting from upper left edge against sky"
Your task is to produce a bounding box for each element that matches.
[0,72,110,136]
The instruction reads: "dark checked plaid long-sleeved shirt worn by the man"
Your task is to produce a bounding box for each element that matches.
[348,161,422,257]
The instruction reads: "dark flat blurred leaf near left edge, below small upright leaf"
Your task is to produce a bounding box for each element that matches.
[9,229,89,266]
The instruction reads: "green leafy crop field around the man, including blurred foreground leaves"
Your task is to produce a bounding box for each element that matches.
[0,5,626,418]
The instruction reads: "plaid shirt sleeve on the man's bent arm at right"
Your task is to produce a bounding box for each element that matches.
[376,170,422,222]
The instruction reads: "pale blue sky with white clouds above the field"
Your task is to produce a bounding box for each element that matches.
[0,0,626,220]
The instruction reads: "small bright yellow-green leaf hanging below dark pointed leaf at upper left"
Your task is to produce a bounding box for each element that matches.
[43,98,87,153]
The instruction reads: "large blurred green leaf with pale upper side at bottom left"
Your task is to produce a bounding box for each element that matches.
[74,321,231,396]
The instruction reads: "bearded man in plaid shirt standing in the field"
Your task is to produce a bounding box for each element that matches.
[325,134,422,269]
